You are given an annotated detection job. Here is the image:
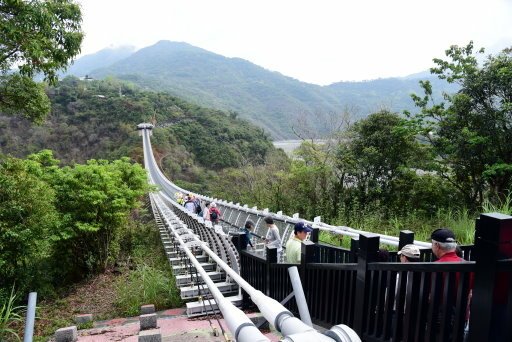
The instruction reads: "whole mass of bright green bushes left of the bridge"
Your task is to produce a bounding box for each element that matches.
[0,150,149,296]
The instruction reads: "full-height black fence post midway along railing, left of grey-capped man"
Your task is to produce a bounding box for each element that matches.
[353,234,379,336]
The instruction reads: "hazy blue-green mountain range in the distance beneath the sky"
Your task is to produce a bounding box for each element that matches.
[66,41,456,139]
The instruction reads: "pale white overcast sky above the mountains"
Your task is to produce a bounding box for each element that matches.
[76,0,512,85]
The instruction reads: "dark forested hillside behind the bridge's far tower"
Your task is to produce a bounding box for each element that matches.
[0,77,272,179]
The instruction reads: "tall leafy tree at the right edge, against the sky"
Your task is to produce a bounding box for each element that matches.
[409,42,512,208]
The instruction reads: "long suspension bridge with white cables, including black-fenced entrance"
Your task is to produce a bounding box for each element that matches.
[138,124,512,341]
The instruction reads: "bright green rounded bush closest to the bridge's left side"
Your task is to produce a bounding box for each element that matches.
[54,158,148,272]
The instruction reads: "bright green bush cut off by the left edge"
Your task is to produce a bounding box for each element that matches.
[0,157,60,291]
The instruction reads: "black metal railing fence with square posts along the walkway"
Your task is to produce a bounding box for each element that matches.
[235,214,512,342]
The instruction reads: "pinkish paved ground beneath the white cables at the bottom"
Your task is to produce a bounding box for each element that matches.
[78,309,281,342]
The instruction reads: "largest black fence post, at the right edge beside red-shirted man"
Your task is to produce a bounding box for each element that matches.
[469,213,512,342]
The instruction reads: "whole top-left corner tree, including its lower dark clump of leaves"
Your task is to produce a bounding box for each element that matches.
[0,0,83,122]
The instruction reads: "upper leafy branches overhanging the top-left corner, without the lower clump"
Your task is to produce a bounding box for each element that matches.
[0,0,83,82]
